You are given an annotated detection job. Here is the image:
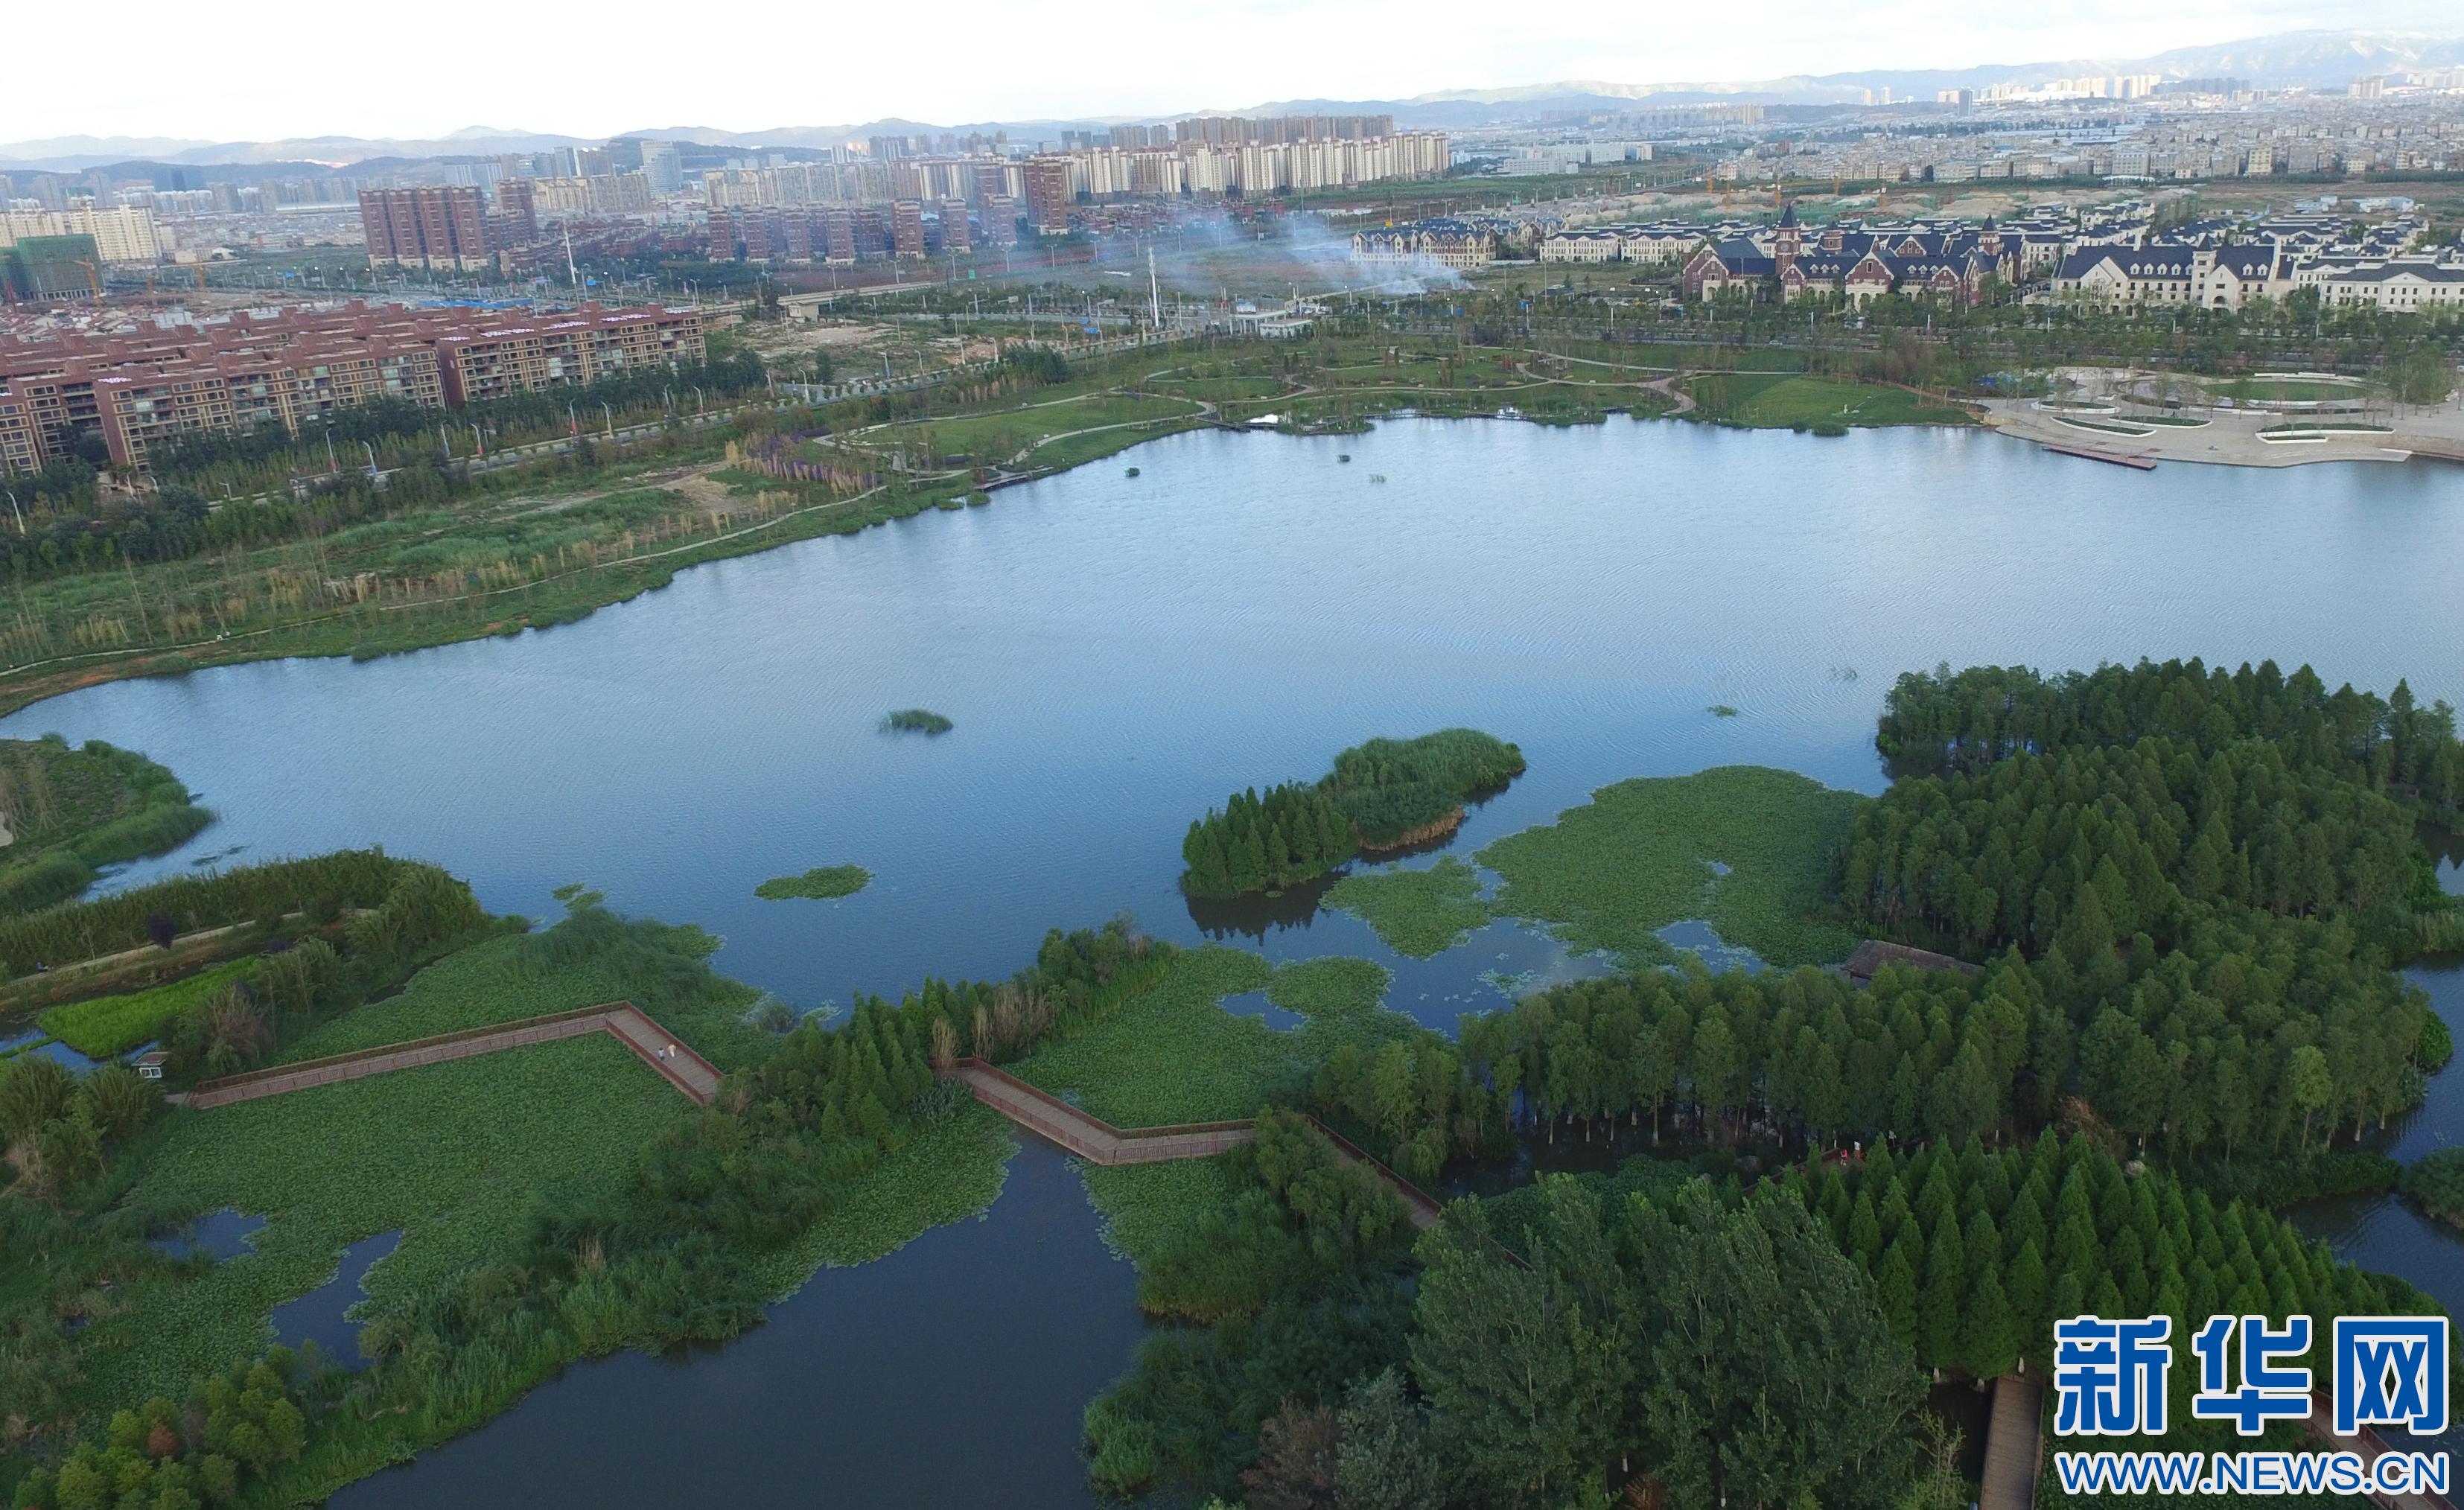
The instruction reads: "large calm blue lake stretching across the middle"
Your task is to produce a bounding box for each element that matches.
[0,416,2464,1505]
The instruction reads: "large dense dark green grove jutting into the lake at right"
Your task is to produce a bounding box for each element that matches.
[1843,660,2464,1156]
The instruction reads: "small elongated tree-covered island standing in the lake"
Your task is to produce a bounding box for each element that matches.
[1180,729,1523,896]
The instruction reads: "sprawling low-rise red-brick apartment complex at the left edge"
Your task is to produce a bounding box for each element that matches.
[0,303,707,473]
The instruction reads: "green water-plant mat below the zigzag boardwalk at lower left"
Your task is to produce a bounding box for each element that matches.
[89,1034,690,1401]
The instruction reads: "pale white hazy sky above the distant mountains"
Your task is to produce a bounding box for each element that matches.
[0,0,2459,141]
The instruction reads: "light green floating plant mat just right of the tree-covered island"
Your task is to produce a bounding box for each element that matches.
[1474,766,1868,966]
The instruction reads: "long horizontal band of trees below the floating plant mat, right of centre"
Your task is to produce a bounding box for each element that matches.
[1311,931,2430,1180]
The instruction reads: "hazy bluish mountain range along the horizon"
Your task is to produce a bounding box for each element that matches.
[0,30,2464,173]
